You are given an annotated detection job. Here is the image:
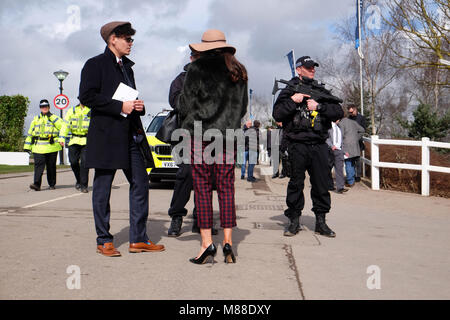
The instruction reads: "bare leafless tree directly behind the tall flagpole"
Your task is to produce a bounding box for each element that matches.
[321,0,406,135]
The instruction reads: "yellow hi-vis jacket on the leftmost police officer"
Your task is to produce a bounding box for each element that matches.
[23,112,63,153]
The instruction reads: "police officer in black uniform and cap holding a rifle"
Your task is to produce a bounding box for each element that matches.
[273,56,343,237]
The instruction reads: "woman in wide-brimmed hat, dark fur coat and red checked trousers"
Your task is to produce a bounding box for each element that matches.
[179,30,248,264]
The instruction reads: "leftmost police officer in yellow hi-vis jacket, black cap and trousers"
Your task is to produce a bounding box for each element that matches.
[23,99,63,191]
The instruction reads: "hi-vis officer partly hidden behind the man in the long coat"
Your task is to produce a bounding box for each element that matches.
[59,103,91,193]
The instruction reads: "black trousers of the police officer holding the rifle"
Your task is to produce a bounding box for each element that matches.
[284,142,331,219]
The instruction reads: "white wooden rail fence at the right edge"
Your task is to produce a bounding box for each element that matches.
[362,136,450,196]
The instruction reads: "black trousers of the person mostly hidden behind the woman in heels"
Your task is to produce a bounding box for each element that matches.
[169,163,197,219]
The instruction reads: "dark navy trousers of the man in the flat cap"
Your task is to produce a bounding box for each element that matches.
[92,141,148,245]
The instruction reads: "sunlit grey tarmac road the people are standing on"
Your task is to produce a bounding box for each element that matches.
[0,166,450,300]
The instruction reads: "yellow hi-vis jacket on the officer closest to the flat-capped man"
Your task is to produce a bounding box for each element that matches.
[59,105,91,146]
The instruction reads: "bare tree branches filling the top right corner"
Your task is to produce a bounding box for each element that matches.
[382,0,450,112]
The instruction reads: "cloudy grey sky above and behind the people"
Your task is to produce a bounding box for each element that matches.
[0,0,355,126]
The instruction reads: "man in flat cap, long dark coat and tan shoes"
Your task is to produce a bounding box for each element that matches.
[79,21,164,257]
